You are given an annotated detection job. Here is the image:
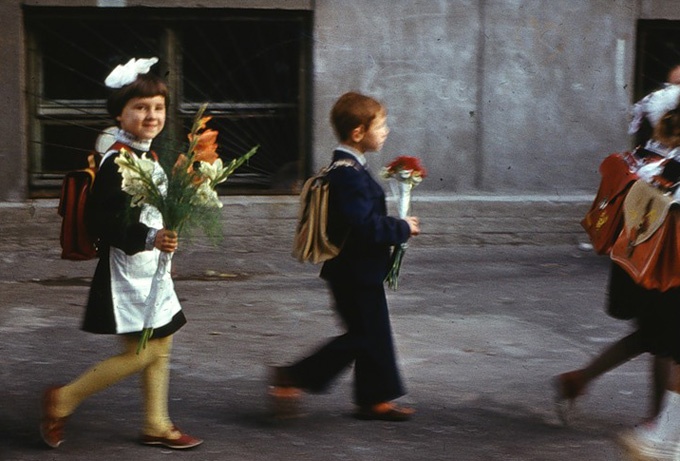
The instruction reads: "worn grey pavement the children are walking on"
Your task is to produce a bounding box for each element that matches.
[0,196,649,461]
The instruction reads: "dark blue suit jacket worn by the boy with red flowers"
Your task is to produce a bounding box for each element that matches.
[321,150,411,285]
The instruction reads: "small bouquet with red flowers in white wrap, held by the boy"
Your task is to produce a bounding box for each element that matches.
[381,156,427,290]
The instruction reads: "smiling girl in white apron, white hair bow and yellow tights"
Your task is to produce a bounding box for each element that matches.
[40,58,202,449]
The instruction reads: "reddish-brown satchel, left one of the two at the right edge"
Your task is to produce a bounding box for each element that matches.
[581,152,638,254]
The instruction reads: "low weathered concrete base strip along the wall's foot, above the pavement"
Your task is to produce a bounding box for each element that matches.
[0,195,590,258]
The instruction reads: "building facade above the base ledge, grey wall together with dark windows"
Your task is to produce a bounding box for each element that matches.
[0,0,680,202]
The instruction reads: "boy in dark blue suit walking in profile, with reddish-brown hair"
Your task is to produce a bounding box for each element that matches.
[271,92,420,421]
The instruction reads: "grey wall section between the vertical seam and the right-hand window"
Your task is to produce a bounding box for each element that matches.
[478,0,634,194]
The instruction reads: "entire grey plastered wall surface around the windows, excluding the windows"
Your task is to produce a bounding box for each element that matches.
[0,0,680,201]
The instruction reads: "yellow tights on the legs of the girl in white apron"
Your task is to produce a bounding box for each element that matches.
[55,336,172,436]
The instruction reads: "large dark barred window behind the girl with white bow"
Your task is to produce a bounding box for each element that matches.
[25,8,311,196]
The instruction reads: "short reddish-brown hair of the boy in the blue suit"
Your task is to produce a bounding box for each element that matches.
[331,91,387,141]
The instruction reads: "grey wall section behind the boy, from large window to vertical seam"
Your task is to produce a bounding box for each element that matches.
[314,0,484,191]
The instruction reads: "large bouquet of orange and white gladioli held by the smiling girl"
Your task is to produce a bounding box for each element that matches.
[115,105,259,353]
